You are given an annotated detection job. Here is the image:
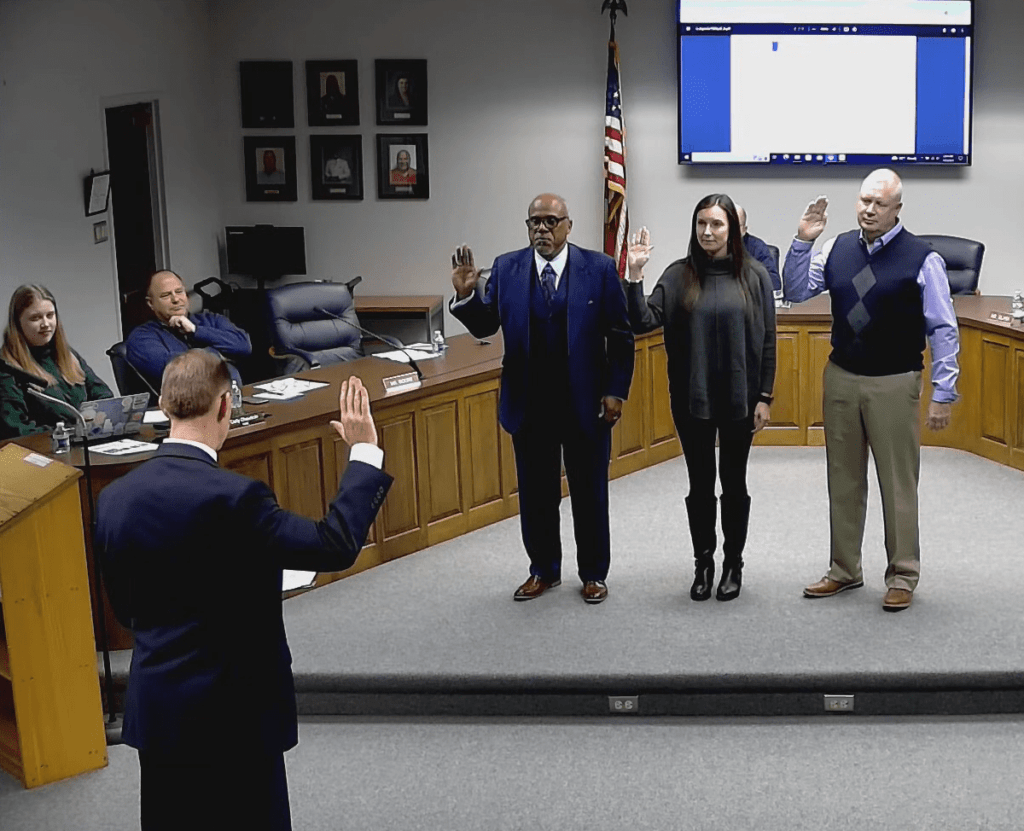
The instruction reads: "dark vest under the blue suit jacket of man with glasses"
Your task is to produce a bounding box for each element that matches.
[529,264,569,407]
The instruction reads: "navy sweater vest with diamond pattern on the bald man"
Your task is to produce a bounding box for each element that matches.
[824,230,932,376]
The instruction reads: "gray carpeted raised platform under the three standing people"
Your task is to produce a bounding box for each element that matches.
[99,447,1024,715]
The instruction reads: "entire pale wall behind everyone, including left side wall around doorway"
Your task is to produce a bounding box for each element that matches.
[0,0,1024,369]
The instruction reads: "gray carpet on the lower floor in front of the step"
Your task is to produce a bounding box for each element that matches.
[0,716,1024,831]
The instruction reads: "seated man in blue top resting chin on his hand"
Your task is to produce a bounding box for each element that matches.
[125,271,252,390]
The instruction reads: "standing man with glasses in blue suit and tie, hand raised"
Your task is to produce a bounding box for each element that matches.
[451,193,634,603]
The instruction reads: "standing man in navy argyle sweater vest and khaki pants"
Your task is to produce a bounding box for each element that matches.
[782,170,959,612]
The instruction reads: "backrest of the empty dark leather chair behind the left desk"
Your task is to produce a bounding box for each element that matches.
[266,277,364,375]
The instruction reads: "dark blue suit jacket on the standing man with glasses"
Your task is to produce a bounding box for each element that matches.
[452,245,634,433]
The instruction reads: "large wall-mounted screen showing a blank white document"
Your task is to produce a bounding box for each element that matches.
[677,0,974,165]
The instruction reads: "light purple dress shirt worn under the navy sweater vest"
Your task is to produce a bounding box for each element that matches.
[782,222,959,404]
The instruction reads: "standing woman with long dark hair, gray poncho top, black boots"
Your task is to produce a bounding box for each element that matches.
[626,193,775,601]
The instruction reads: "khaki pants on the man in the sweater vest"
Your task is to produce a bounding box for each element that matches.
[822,361,921,592]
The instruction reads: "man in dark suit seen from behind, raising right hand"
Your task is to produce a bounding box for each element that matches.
[96,350,391,831]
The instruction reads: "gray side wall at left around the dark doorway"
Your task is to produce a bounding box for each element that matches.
[0,0,222,382]
